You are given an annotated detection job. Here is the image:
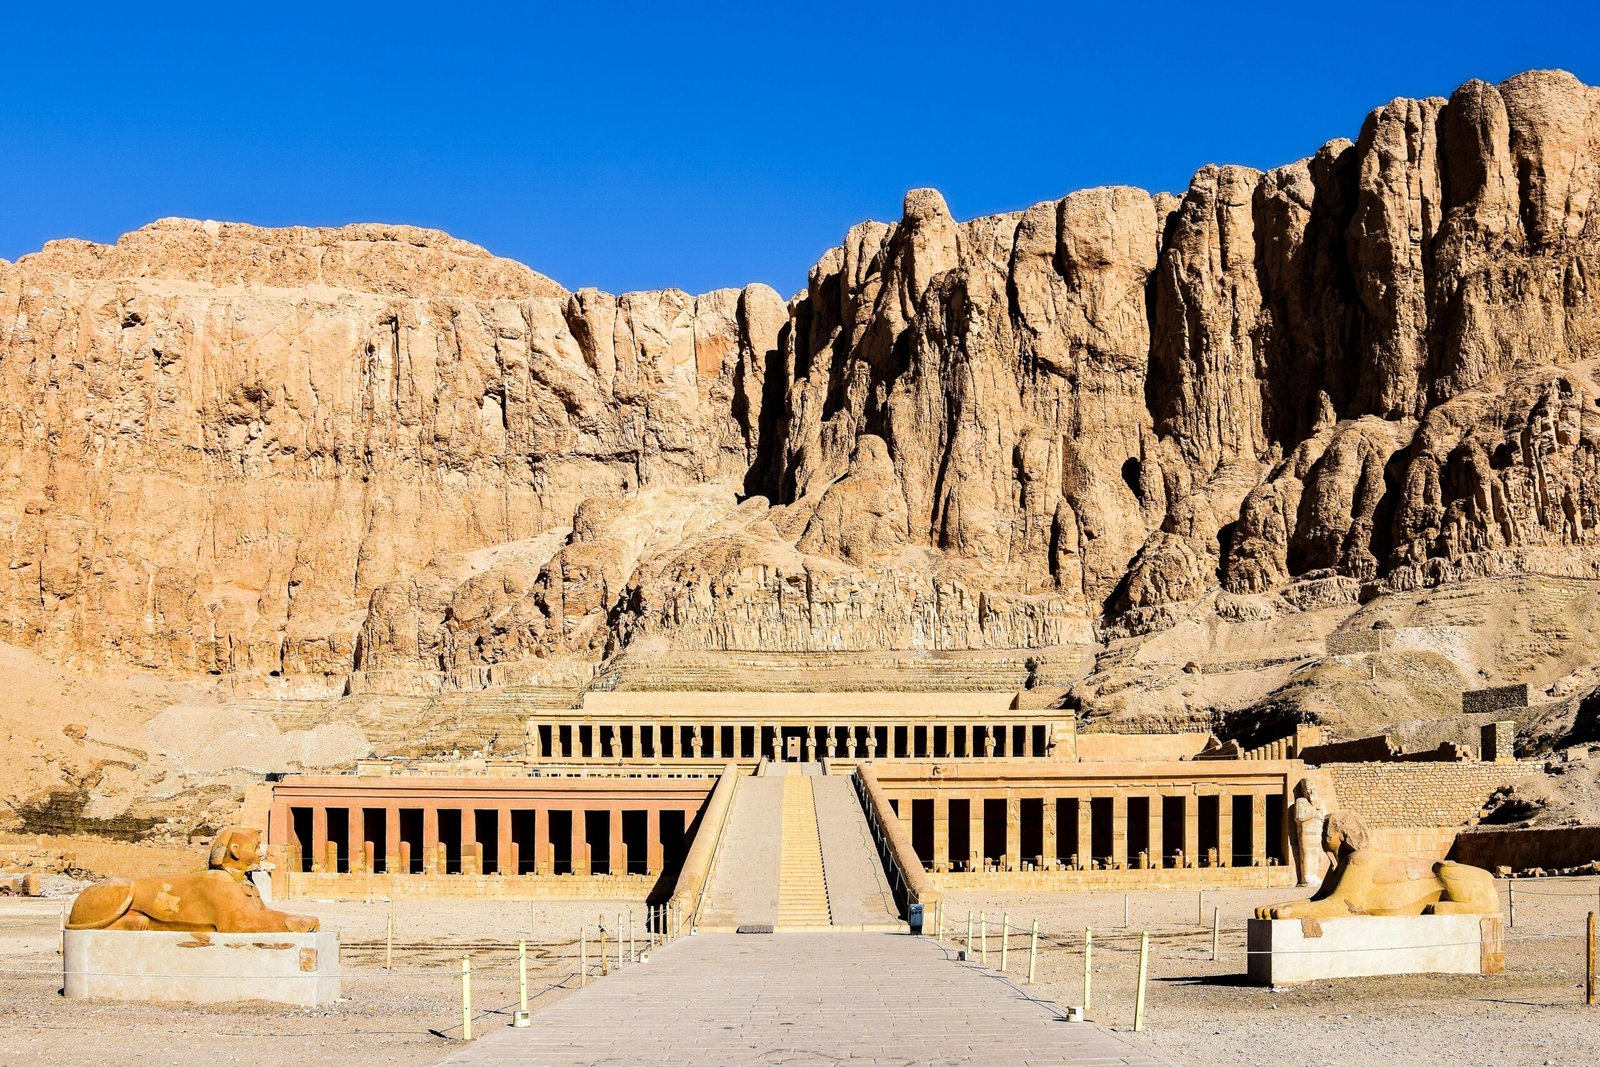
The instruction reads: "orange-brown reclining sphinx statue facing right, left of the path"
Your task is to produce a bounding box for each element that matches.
[67,829,318,934]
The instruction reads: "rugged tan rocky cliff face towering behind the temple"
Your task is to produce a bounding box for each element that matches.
[0,72,1600,688]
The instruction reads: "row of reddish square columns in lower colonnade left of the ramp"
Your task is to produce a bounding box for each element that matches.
[274,805,668,875]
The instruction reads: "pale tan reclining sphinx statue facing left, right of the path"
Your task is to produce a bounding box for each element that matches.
[1256,811,1499,918]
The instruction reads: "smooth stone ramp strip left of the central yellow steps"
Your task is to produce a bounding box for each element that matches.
[699,777,787,931]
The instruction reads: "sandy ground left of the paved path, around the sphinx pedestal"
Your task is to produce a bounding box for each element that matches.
[0,899,645,1067]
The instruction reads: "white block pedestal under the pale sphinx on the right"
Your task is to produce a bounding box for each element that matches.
[1246,915,1506,985]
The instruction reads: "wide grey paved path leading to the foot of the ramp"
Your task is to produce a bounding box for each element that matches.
[445,933,1165,1067]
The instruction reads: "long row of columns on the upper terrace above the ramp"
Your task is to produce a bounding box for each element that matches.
[528,721,1054,761]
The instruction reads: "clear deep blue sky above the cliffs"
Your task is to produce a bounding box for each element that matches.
[0,0,1600,294]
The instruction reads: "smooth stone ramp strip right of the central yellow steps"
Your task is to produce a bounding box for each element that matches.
[813,774,904,929]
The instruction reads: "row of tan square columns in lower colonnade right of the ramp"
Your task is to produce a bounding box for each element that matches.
[896,790,1288,870]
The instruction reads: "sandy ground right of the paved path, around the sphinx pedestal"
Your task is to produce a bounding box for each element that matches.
[946,878,1600,1067]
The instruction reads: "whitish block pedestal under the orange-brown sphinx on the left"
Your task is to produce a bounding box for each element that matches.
[61,929,339,1008]
